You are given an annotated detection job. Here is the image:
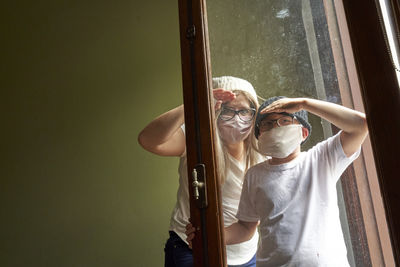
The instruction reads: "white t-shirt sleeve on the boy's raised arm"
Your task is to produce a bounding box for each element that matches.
[313,131,361,182]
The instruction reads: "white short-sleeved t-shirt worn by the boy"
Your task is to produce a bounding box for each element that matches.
[236,133,360,267]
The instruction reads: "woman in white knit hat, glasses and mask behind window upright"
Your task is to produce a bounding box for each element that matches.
[138,76,262,267]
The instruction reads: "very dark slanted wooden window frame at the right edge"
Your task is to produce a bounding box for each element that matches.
[342,0,400,265]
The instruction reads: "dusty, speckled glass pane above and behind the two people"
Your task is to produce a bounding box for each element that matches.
[207,0,376,266]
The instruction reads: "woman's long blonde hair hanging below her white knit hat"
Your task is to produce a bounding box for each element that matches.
[215,90,261,184]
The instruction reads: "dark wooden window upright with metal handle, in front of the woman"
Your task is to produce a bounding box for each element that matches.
[178,0,226,267]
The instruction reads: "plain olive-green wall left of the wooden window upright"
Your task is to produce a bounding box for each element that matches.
[0,0,182,267]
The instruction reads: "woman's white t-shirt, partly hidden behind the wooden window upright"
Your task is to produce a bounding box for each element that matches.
[169,126,258,265]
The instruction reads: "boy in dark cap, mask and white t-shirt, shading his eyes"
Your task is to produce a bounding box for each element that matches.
[188,97,368,267]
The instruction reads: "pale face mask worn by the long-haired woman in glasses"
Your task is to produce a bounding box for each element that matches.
[217,115,253,144]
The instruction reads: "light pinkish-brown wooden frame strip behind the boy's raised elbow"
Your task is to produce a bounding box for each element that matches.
[324,0,394,267]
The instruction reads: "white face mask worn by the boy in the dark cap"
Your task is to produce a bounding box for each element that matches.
[258,124,303,158]
